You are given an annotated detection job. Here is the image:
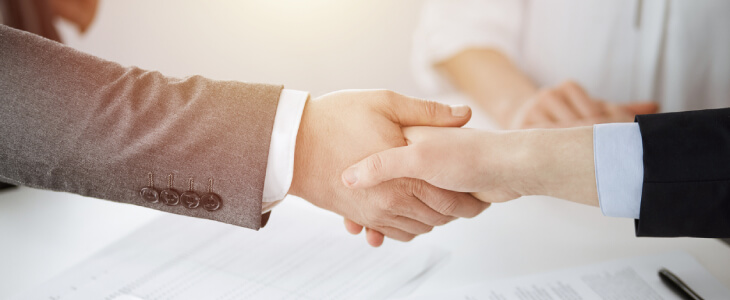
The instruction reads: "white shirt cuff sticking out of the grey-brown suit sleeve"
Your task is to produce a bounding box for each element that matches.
[262,89,309,205]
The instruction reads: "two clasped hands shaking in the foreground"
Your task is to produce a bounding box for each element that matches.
[289,91,598,247]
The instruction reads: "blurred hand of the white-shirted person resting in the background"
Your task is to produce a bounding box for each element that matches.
[511,81,659,129]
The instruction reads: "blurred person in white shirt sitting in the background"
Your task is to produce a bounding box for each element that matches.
[414,0,730,129]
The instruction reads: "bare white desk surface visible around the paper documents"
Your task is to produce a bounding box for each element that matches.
[0,99,730,299]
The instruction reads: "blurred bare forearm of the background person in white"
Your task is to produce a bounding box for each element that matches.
[437,49,537,128]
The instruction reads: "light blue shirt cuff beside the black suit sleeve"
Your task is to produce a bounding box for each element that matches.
[593,123,644,219]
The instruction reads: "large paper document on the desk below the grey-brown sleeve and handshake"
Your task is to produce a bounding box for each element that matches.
[15,209,445,300]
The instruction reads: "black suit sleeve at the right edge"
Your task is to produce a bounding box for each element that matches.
[636,108,730,237]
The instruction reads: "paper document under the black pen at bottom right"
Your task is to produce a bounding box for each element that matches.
[408,252,730,300]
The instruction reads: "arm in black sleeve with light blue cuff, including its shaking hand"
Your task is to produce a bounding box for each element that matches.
[342,109,730,238]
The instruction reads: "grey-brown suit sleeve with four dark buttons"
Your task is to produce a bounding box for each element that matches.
[0,25,282,229]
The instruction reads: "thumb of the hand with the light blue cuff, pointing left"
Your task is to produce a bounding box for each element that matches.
[342,146,419,189]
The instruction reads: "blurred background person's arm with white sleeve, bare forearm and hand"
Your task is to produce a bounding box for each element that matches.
[413,0,657,129]
